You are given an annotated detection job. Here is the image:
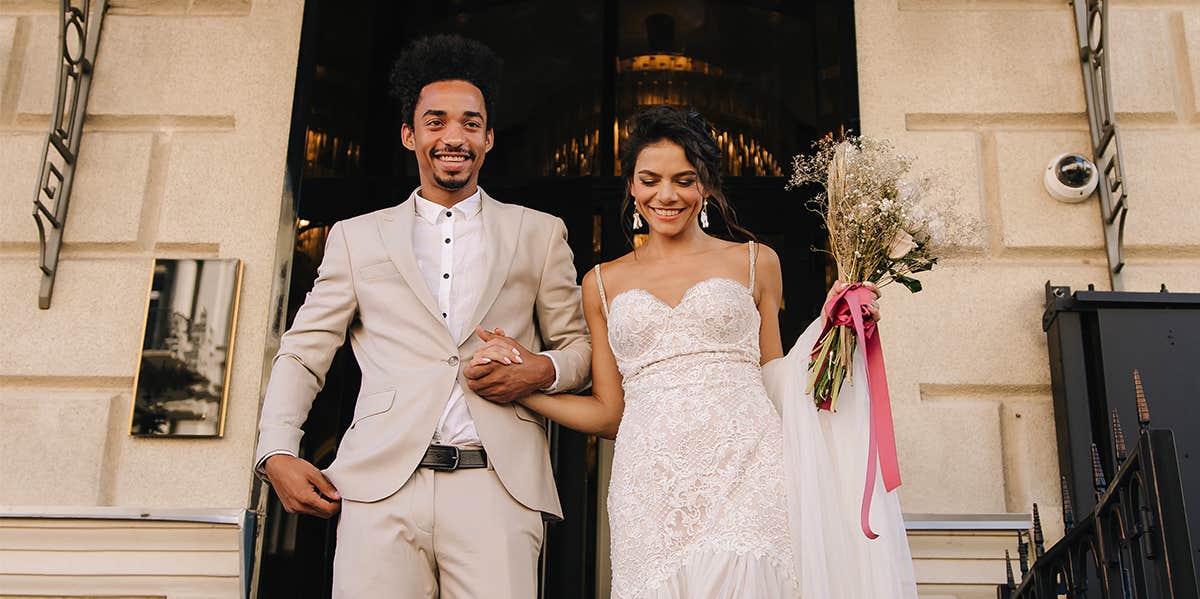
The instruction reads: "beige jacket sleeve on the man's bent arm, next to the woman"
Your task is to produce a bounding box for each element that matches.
[535,218,592,391]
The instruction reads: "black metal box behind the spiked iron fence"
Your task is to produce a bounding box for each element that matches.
[1042,282,1200,580]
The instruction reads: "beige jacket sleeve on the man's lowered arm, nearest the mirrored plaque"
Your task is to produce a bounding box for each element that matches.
[254,223,358,469]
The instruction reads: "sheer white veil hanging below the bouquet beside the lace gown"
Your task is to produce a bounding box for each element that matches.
[762,317,917,599]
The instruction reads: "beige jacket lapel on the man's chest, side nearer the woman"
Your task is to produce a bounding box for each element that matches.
[458,190,524,346]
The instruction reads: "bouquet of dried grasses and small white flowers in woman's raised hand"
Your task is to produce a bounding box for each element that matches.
[788,136,965,411]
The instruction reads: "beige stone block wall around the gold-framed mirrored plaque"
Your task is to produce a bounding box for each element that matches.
[0,0,302,518]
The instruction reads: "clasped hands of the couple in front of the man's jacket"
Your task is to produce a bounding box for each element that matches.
[463,328,554,403]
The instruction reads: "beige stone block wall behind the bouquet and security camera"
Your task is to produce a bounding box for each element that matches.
[856,0,1200,597]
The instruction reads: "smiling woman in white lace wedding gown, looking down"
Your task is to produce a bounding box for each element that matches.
[473,107,916,599]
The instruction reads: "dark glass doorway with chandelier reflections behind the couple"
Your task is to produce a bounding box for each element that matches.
[258,0,858,598]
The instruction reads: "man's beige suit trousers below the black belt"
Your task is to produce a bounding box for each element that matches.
[334,468,544,599]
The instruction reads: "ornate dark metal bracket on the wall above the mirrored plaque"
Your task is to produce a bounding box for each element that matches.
[34,0,108,310]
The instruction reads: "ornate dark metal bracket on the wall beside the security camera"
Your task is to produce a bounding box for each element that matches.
[1070,0,1129,290]
